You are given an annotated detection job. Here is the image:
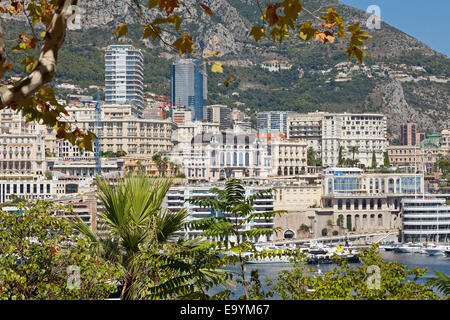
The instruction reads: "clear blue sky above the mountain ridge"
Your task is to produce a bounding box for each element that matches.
[339,0,450,57]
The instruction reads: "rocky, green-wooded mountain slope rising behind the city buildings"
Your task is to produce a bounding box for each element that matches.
[2,0,450,139]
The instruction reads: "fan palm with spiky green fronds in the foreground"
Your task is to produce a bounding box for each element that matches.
[73,175,188,299]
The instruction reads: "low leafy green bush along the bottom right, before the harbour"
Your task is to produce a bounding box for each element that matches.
[273,245,439,300]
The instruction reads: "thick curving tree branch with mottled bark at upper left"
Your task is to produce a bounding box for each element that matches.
[0,0,78,109]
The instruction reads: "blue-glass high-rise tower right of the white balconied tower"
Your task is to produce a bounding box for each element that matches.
[170,57,208,120]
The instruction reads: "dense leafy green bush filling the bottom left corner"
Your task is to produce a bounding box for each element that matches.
[0,201,117,300]
